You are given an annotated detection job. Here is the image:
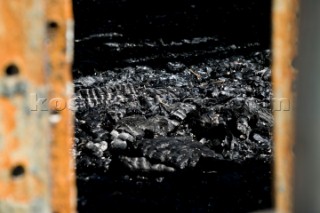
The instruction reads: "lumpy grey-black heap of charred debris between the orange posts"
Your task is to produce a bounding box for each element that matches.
[75,43,273,172]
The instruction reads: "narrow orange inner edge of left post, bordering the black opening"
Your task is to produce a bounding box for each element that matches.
[46,0,76,213]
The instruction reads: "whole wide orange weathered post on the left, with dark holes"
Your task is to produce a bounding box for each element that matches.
[0,0,76,213]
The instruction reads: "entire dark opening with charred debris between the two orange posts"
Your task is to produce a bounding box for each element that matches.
[74,0,273,212]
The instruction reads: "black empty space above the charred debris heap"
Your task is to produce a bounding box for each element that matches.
[74,0,271,73]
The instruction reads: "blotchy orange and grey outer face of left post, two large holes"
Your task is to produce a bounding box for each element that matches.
[0,0,51,213]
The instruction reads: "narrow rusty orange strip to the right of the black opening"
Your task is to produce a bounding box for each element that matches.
[272,0,298,213]
